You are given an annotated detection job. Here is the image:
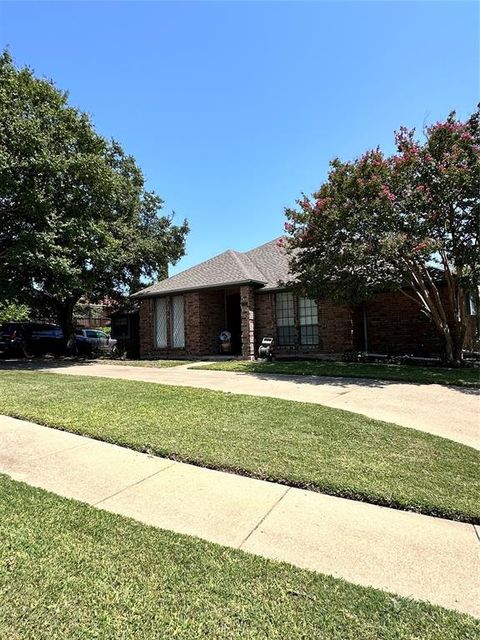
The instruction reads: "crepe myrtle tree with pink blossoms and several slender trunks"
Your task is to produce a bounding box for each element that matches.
[284,109,480,365]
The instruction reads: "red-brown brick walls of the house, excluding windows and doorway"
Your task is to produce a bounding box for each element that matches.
[139,287,475,358]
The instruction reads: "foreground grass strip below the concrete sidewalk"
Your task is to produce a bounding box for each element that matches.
[0,475,480,640]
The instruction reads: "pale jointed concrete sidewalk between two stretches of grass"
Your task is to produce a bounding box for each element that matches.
[0,416,480,617]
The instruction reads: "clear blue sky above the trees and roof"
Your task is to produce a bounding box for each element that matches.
[0,0,479,273]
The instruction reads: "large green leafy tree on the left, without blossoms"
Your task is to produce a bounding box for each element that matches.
[0,52,188,335]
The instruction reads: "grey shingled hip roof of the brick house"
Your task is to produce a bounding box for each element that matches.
[132,238,289,297]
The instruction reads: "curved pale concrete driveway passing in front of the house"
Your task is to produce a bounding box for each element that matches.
[16,362,480,449]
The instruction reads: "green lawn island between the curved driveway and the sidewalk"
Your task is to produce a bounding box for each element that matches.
[0,371,480,523]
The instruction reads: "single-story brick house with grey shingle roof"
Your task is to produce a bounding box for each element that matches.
[132,240,480,358]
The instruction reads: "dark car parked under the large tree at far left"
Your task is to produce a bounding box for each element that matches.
[0,322,65,358]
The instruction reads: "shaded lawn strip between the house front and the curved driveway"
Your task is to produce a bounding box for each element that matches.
[191,360,480,388]
